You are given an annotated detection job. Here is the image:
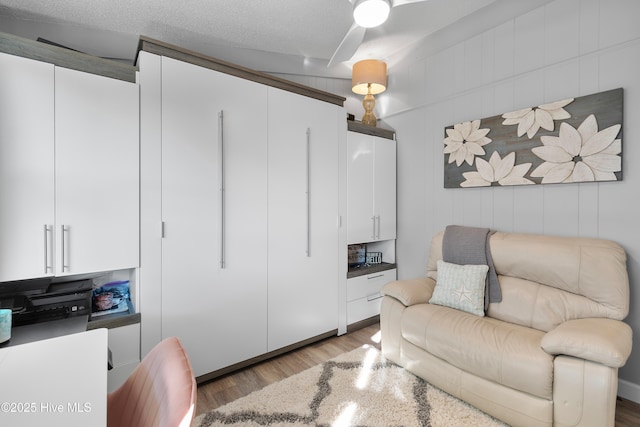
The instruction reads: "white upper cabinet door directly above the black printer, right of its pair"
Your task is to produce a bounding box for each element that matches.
[55,67,140,275]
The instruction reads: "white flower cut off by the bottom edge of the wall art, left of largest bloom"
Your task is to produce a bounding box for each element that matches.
[460,151,535,187]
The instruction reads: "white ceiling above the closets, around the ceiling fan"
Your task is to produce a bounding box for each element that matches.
[0,0,548,75]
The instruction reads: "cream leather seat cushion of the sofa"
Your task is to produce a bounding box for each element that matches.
[401,304,553,399]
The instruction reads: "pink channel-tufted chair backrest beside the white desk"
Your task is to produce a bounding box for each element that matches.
[107,337,196,427]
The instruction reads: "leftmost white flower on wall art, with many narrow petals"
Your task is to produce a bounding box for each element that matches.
[444,120,491,166]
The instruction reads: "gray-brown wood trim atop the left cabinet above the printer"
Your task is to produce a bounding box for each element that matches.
[0,32,138,83]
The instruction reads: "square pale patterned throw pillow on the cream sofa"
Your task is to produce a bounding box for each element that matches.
[429,260,489,316]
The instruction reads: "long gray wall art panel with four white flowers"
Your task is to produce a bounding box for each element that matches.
[444,88,623,188]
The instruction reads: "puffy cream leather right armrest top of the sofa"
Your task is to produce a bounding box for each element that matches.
[541,318,632,368]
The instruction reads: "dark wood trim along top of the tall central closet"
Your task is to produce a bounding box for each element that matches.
[136,36,346,107]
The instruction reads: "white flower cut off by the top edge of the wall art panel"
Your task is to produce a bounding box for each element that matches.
[502,98,574,139]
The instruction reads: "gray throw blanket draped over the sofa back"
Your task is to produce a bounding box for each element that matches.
[442,225,502,310]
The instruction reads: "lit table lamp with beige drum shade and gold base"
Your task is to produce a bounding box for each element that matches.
[351,59,387,126]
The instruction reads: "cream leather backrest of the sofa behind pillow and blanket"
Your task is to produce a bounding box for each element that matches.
[427,232,629,331]
